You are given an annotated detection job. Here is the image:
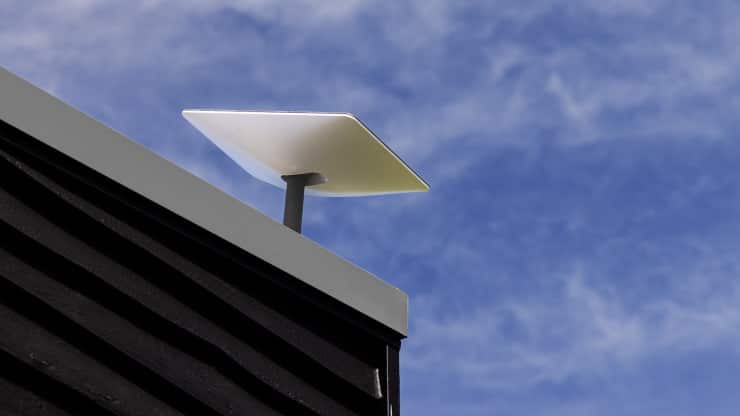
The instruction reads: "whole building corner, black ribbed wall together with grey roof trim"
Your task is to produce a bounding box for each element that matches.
[0,69,407,415]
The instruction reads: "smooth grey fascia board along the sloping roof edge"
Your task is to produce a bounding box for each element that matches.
[0,68,408,335]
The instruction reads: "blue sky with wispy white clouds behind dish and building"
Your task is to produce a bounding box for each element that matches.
[0,0,740,416]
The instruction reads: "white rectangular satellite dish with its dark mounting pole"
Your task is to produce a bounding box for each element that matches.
[182,110,429,232]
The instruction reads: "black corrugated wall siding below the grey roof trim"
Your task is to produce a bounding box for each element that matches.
[0,124,401,415]
